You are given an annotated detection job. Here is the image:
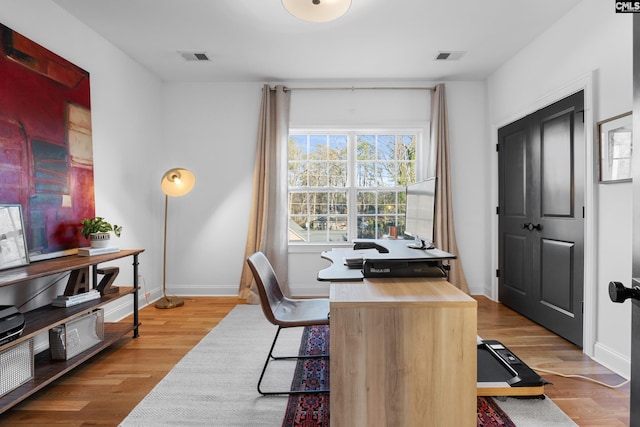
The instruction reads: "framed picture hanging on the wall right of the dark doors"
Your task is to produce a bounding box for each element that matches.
[598,111,633,183]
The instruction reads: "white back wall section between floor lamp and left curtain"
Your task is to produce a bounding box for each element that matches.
[160,83,262,295]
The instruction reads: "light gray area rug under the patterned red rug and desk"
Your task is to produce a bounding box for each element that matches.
[120,305,576,427]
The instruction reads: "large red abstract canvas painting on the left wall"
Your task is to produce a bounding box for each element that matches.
[0,24,95,261]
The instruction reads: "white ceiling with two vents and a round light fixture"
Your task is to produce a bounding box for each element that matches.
[54,0,580,82]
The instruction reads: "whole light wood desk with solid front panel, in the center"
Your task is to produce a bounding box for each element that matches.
[330,278,477,427]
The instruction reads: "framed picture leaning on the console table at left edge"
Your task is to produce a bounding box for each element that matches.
[0,204,29,270]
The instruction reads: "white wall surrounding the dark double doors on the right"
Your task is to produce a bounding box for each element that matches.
[487,0,632,375]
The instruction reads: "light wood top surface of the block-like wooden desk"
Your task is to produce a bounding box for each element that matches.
[329,277,477,307]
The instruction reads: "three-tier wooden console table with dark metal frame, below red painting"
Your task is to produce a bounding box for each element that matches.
[0,249,144,413]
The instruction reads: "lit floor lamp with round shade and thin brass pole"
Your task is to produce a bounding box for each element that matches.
[156,168,196,308]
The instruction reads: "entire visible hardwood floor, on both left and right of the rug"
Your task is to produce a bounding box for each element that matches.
[0,297,629,427]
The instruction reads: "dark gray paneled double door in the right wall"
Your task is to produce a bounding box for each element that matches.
[498,92,585,346]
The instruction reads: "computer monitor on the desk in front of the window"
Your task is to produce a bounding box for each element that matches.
[405,177,436,247]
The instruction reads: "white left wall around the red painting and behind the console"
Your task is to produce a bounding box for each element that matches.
[1,0,163,320]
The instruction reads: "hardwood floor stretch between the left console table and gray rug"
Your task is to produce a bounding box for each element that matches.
[0,298,241,427]
